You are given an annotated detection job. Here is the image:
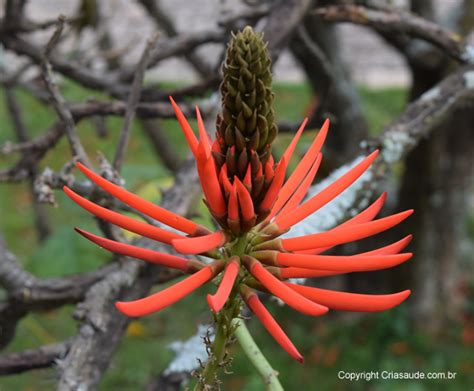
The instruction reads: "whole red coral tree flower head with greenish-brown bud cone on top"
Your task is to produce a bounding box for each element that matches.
[64,28,413,362]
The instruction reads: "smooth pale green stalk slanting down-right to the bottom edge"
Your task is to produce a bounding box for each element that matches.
[232,318,283,391]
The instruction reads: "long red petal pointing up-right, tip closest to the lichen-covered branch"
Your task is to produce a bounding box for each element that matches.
[274,150,379,229]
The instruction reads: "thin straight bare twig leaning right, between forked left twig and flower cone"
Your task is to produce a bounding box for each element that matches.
[113,34,158,172]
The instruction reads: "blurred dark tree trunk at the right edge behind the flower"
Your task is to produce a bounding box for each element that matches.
[395,2,474,334]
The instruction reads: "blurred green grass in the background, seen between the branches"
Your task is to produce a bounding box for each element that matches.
[0,83,474,391]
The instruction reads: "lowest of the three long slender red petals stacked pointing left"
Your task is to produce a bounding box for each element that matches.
[75,228,189,271]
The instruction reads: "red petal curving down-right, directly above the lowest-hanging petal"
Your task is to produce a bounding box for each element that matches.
[244,257,328,316]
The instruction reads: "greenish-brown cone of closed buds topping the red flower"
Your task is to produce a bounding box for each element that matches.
[217,26,277,177]
